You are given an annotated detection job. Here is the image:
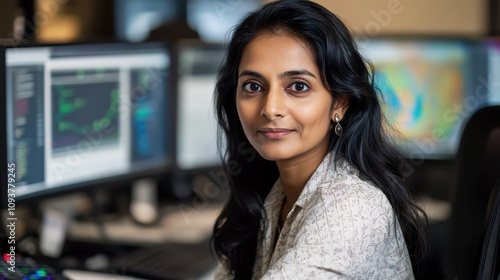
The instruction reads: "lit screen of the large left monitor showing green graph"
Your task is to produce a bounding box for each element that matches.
[2,43,170,200]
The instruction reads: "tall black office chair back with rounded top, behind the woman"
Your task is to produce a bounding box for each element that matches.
[443,106,500,280]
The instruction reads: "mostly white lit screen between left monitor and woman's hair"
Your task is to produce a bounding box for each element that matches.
[176,41,225,170]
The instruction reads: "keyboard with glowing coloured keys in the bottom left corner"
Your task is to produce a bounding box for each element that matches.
[0,256,69,280]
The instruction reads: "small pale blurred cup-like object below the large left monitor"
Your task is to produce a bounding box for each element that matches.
[130,179,159,225]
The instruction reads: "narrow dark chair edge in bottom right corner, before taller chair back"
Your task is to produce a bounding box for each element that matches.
[475,178,500,280]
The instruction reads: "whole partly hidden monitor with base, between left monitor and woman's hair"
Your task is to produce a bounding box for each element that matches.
[163,39,227,203]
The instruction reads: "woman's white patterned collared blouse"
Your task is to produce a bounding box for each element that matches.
[215,153,414,280]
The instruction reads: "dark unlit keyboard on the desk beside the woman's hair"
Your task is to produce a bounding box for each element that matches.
[108,242,217,280]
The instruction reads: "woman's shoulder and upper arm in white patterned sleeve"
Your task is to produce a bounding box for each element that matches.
[290,160,412,279]
